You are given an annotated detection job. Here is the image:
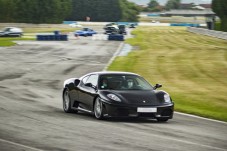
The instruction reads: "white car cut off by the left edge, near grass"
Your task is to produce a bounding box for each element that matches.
[0,27,23,37]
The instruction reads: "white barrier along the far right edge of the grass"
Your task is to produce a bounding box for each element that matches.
[188,27,227,40]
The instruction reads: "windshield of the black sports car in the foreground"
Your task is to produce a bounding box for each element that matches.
[98,74,153,90]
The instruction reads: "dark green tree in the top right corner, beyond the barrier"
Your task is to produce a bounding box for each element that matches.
[212,0,227,32]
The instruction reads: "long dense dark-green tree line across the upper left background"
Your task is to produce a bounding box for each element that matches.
[0,0,140,23]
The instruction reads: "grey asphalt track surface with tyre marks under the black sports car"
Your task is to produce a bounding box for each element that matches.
[0,31,227,151]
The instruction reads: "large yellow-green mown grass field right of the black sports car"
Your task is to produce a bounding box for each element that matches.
[108,27,227,121]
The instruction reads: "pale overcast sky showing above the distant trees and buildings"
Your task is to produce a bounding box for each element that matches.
[128,0,212,5]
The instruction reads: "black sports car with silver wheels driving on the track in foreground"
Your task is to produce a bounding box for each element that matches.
[62,72,174,121]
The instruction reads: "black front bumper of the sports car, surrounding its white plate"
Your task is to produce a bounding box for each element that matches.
[103,102,174,119]
